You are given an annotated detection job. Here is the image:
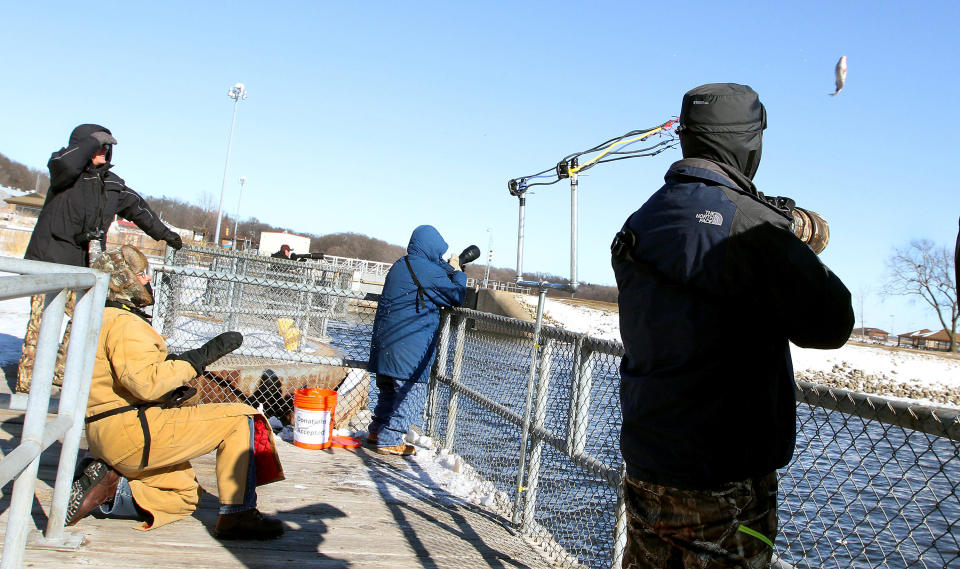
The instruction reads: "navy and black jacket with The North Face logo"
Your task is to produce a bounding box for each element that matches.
[613,84,853,489]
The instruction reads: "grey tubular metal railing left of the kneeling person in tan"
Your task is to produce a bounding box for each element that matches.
[0,257,109,568]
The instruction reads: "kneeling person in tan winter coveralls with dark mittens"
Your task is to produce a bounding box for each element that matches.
[67,245,283,539]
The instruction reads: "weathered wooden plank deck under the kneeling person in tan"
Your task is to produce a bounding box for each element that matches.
[0,411,553,569]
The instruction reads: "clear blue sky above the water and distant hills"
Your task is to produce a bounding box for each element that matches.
[0,2,960,332]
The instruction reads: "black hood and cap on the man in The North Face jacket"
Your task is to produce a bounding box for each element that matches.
[678,83,767,180]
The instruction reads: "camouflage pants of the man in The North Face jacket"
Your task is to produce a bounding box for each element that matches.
[623,473,777,569]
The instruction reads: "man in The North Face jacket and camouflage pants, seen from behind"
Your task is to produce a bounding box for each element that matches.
[611,83,853,569]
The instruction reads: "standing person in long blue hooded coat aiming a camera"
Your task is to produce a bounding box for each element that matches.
[367,225,467,456]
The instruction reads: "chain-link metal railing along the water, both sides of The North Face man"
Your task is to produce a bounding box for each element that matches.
[426,309,960,569]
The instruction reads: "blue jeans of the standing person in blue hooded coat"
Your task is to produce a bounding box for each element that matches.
[369,373,427,447]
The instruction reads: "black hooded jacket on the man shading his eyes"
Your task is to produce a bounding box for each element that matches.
[24,124,174,267]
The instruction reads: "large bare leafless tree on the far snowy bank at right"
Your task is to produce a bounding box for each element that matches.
[886,239,960,351]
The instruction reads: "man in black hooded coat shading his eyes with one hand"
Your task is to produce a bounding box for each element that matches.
[17,124,183,392]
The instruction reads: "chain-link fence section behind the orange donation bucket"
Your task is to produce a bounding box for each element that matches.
[153,245,379,428]
